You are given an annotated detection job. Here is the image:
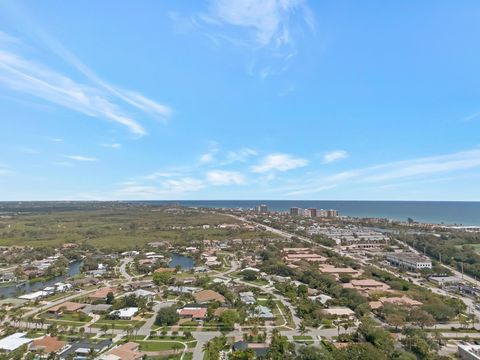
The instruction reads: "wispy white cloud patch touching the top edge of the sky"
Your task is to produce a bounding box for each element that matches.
[188,0,316,80]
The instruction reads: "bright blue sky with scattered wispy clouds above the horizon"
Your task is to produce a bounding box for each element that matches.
[0,0,480,200]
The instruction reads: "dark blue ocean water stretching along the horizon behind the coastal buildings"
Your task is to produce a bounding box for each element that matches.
[147,200,480,226]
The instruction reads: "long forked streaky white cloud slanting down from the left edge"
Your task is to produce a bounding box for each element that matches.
[0,30,172,136]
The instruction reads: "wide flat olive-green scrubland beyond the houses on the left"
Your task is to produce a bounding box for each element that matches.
[0,205,271,249]
